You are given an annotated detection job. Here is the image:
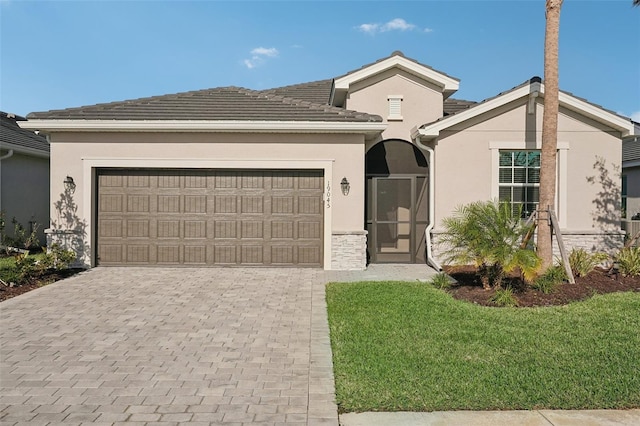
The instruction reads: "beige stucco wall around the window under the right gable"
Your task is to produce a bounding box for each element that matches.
[435,99,621,232]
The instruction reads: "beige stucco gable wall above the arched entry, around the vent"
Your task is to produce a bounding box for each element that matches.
[346,69,443,140]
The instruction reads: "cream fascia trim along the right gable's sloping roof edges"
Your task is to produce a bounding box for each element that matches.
[412,77,634,139]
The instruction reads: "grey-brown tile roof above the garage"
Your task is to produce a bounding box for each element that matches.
[27,84,382,122]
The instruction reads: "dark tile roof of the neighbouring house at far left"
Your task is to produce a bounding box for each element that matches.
[0,112,49,157]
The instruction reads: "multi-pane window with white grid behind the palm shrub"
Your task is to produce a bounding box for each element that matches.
[498,149,540,218]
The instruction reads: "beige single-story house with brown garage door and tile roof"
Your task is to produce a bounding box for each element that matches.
[21,52,633,269]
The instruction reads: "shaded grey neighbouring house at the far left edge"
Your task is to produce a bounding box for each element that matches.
[0,112,49,246]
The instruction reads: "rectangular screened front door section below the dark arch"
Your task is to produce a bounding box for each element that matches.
[367,175,427,263]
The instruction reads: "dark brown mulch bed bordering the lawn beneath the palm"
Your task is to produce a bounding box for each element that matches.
[445,266,640,307]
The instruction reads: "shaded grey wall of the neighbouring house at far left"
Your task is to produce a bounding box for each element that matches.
[0,150,49,245]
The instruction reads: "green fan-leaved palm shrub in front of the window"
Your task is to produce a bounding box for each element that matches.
[440,201,540,289]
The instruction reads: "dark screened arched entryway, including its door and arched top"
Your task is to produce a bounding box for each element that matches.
[365,139,429,263]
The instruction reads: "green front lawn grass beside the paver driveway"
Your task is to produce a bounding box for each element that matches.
[327,282,640,412]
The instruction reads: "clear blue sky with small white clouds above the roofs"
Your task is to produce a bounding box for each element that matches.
[0,0,640,121]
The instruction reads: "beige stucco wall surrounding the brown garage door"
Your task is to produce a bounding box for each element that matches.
[46,133,364,268]
